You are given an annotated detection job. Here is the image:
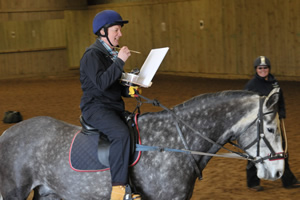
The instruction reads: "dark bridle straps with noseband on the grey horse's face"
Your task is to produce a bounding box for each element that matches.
[243,97,286,163]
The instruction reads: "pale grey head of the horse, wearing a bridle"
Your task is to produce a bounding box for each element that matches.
[238,88,285,180]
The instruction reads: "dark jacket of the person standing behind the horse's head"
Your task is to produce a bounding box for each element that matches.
[244,74,286,119]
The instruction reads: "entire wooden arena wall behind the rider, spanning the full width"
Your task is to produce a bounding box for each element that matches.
[0,0,300,80]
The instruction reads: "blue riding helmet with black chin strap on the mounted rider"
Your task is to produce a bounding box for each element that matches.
[93,10,128,46]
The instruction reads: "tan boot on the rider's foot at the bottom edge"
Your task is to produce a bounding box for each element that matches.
[110,185,142,200]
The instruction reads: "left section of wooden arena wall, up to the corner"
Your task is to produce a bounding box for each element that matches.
[0,0,88,78]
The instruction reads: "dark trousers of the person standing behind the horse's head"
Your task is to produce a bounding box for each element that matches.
[246,139,297,187]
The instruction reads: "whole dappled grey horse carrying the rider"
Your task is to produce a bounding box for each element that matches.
[0,89,284,200]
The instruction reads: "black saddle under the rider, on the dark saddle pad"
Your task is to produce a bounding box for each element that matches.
[72,112,140,168]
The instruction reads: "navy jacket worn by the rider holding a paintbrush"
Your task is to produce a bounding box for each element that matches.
[80,39,128,115]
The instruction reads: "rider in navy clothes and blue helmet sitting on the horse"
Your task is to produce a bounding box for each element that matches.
[80,10,141,200]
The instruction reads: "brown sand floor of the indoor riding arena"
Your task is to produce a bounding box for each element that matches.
[0,75,300,200]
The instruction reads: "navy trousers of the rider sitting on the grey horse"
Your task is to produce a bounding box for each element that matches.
[82,109,130,186]
